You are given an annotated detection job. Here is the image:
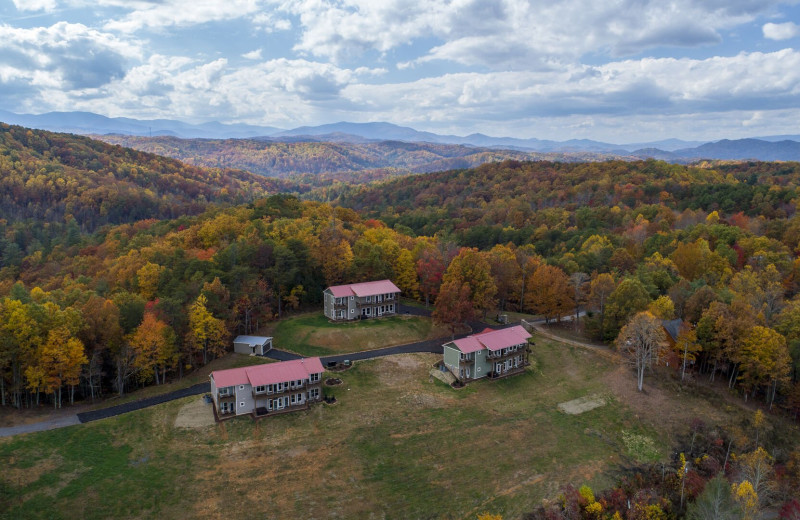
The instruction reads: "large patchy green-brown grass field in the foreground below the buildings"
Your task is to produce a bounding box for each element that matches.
[0,340,768,519]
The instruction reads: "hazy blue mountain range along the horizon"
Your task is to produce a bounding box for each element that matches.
[0,110,800,163]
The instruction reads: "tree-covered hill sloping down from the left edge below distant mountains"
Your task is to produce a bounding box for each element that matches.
[0,124,298,230]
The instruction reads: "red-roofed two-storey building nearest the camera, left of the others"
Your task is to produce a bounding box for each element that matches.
[209,357,324,420]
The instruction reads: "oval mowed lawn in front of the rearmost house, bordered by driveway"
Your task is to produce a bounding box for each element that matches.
[267,312,450,356]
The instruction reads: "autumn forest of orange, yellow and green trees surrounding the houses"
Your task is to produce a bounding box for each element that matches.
[0,126,800,518]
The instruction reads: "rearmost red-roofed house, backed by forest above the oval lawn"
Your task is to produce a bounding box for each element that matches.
[322,280,400,321]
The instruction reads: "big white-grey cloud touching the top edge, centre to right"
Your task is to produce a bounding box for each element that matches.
[283,0,782,69]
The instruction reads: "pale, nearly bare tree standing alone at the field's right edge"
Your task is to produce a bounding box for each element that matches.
[617,311,666,392]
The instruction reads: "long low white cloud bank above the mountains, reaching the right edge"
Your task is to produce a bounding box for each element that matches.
[341,49,800,129]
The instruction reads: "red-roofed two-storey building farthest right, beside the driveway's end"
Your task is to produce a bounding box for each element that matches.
[443,325,531,383]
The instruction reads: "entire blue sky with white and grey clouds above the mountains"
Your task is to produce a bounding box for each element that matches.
[0,0,800,143]
